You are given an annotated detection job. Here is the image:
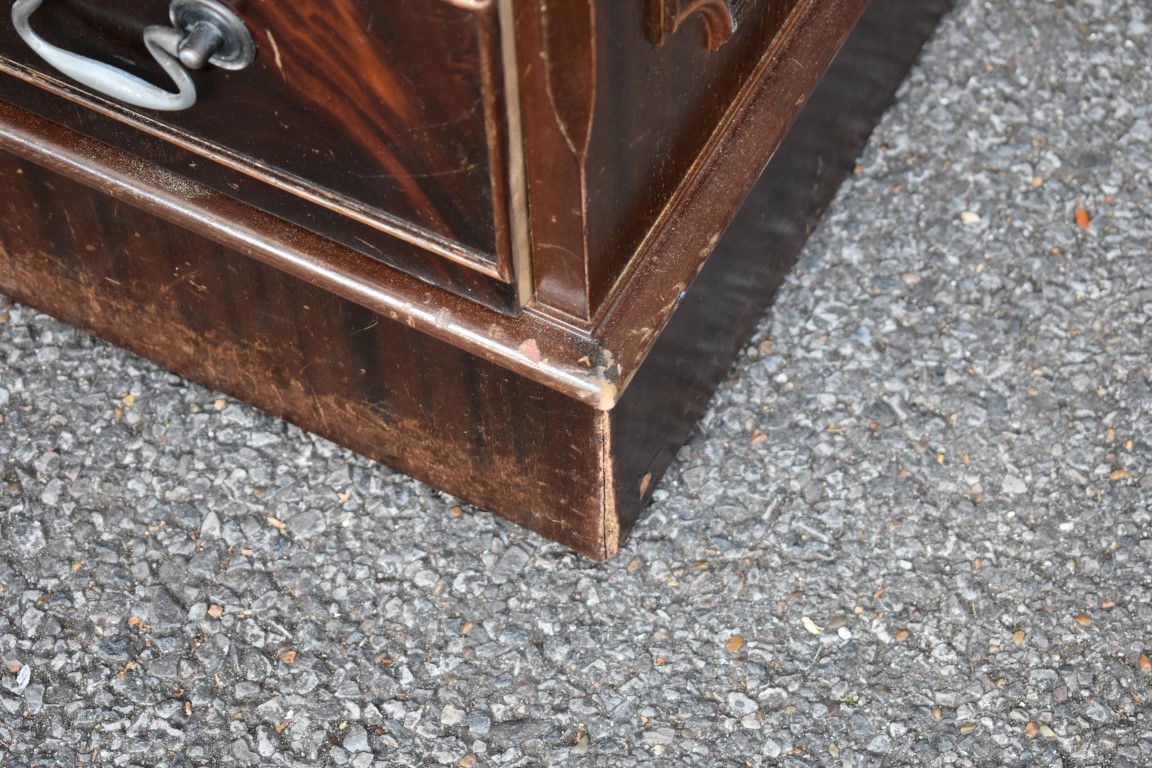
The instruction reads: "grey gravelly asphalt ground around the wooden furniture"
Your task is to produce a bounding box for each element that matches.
[0,0,1152,768]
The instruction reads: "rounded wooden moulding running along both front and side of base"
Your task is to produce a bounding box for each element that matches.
[0,0,926,411]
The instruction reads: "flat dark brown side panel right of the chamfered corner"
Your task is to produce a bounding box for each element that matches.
[588,0,811,311]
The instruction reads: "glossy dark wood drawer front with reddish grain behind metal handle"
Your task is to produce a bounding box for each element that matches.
[0,0,516,310]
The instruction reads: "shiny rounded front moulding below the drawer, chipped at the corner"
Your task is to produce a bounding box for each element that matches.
[0,104,619,410]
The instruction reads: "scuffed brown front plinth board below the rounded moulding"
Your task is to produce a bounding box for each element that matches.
[0,147,617,557]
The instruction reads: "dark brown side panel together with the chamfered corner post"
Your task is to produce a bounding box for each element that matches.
[517,0,811,319]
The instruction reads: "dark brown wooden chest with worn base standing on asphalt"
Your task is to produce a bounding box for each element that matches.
[0,0,946,557]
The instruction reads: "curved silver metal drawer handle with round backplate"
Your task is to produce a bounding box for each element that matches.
[12,0,256,112]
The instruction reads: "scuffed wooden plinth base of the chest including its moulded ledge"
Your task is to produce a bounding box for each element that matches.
[0,0,946,557]
